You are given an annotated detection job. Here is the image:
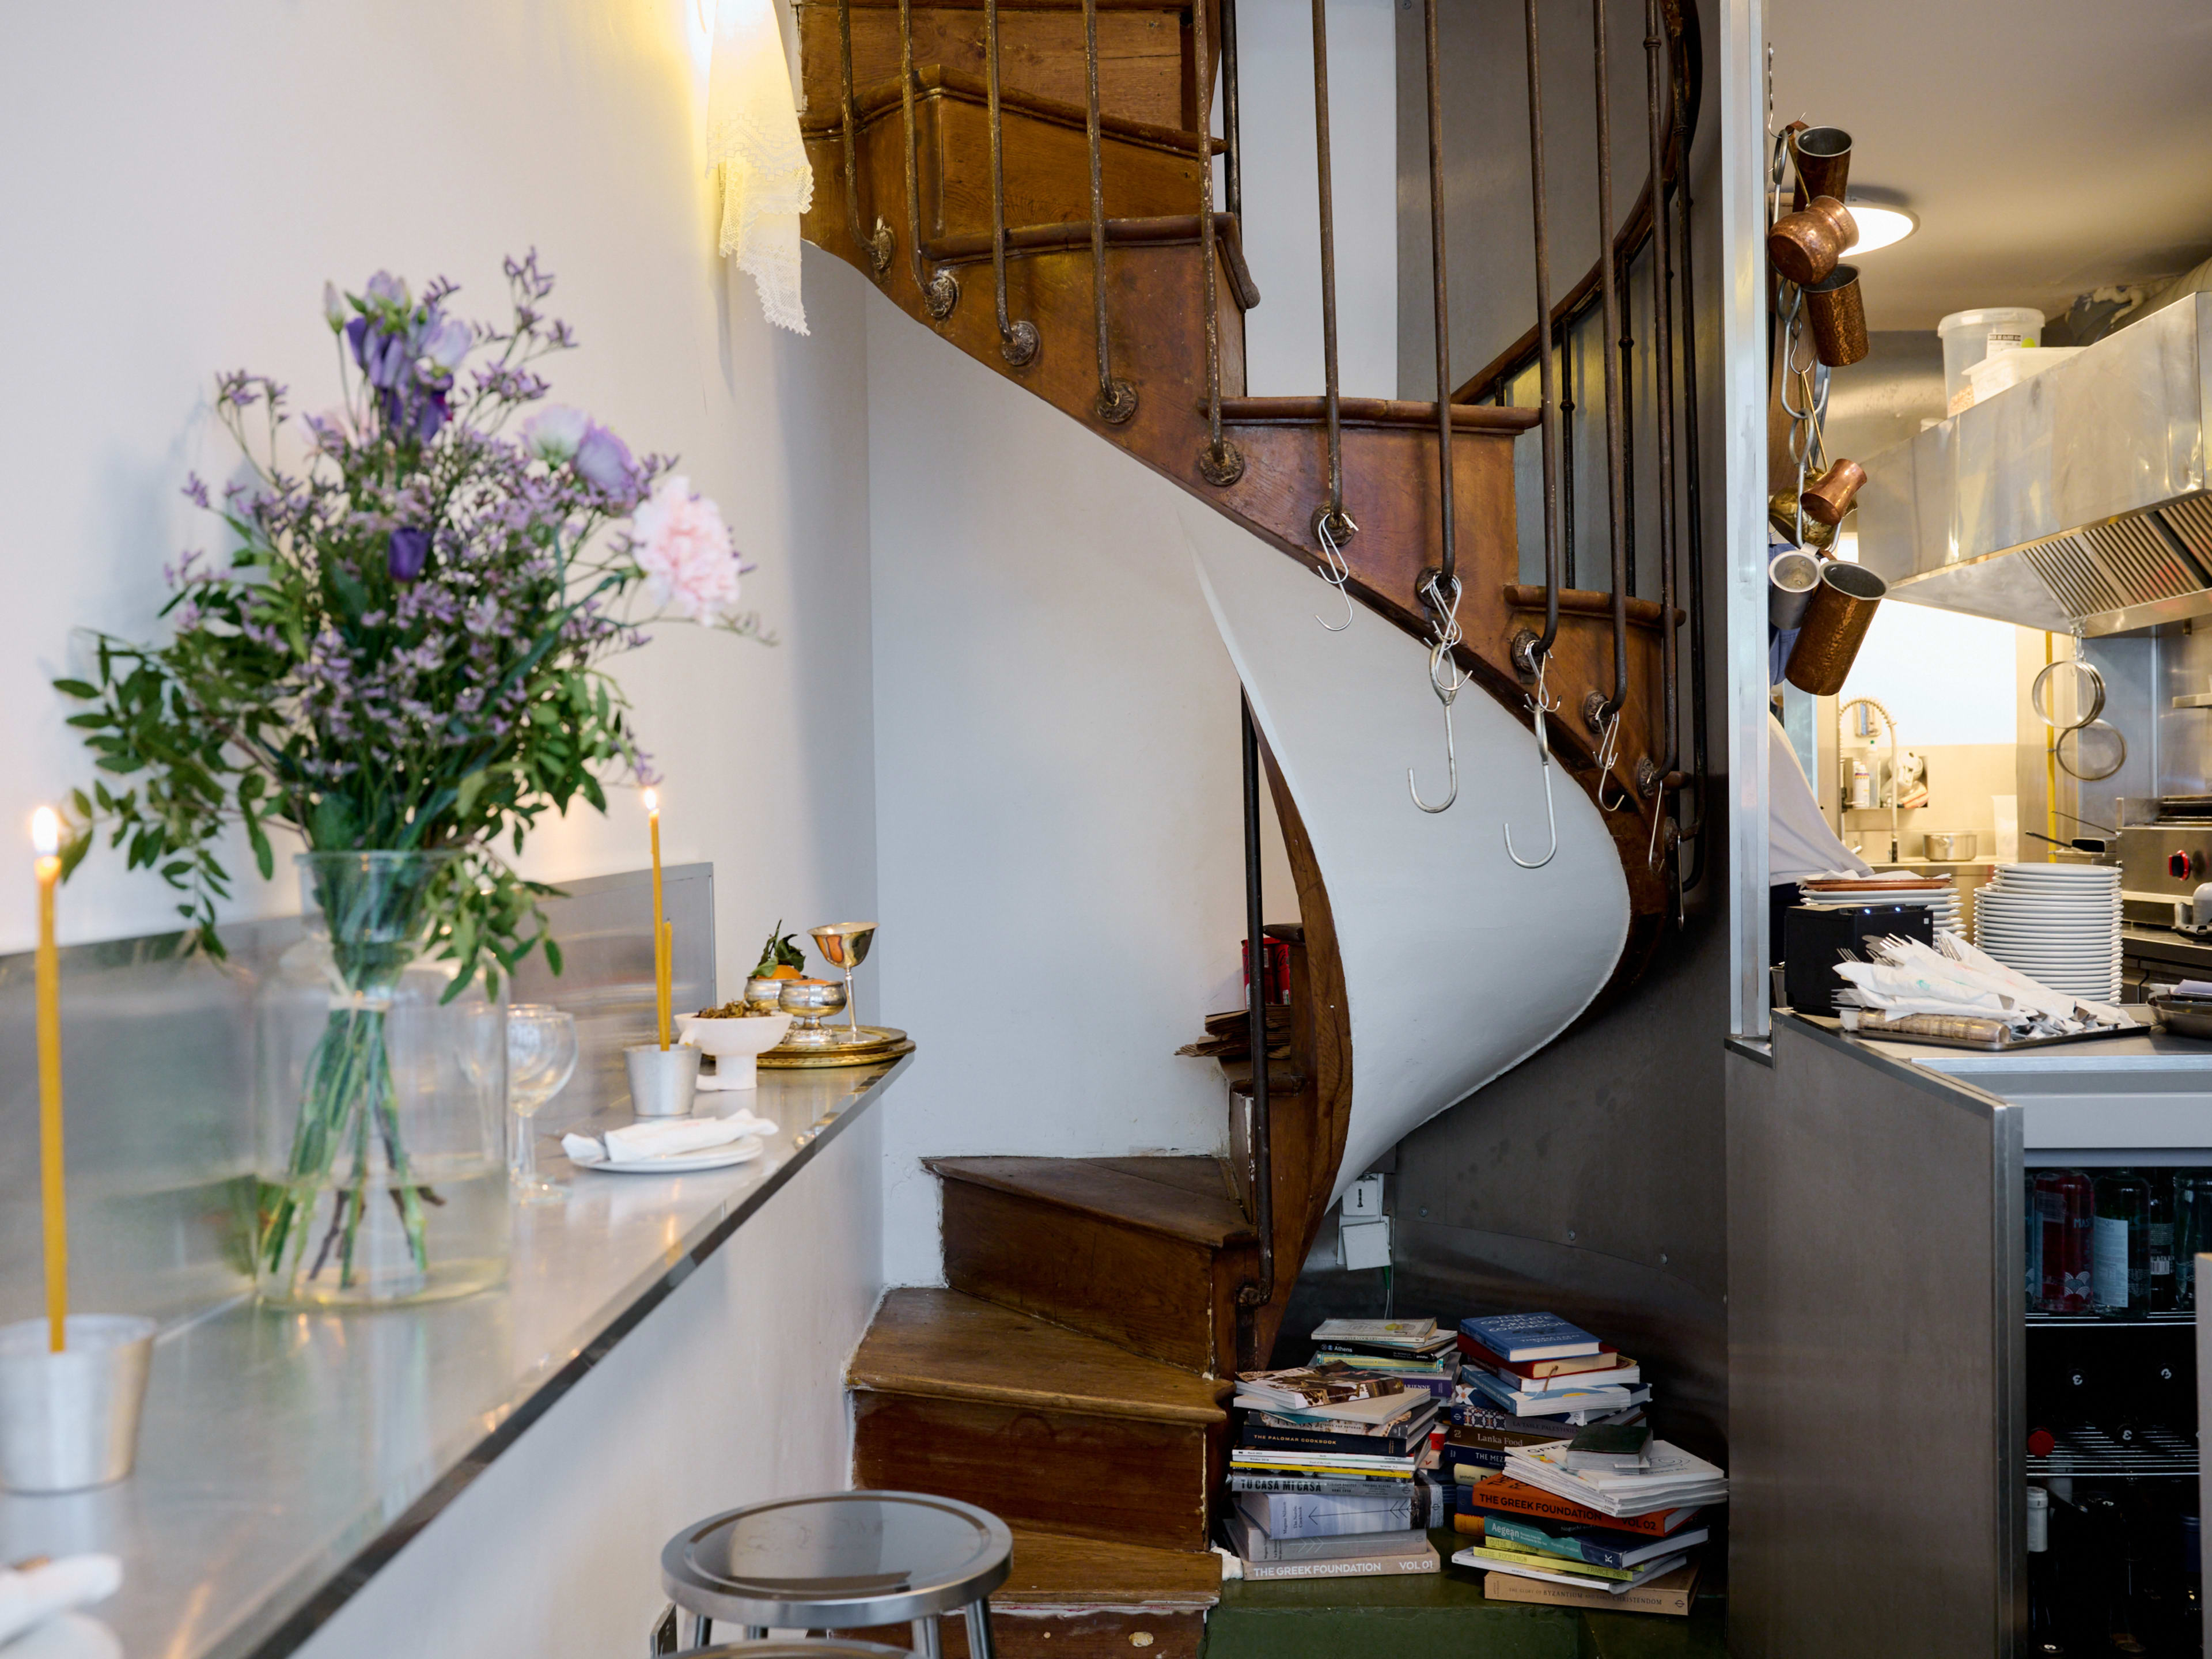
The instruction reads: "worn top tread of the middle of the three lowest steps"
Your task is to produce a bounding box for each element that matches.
[845,1287,1232,1425]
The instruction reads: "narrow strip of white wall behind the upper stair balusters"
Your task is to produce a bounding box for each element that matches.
[1237,0,1398,398]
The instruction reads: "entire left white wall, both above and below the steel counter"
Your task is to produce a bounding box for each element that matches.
[0,0,896,1659]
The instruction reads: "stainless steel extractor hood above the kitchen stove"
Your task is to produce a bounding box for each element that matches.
[1858,294,2212,635]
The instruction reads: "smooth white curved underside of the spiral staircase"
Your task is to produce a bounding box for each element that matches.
[1177,498,1630,1212]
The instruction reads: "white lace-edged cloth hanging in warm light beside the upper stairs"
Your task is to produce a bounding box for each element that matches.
[706,0,814,334]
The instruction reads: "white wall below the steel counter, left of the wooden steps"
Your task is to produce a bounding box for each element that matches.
[298,1106,903,1659]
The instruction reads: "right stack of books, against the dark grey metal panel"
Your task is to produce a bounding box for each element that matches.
[1445,1314,1728,1615]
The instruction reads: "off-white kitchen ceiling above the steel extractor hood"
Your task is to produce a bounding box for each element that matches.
[1765,0,2212,329]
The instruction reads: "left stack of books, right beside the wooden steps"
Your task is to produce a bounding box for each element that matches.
[1224,1365,1442,1580]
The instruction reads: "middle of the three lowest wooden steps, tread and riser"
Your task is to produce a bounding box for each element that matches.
[845,1290,1230,1551]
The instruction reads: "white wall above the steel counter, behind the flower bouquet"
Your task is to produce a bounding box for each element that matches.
[0,0,874,999]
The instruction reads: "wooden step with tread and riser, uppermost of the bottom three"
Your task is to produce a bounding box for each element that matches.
[922,1157,1259,1376]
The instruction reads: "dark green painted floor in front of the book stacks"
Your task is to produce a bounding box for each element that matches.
[1206,1528,1728,1659]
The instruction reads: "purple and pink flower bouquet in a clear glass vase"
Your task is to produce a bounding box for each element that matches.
[55,255,772,1303]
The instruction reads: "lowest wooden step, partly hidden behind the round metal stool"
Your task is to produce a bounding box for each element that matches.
[851,1527,1221,1659]
